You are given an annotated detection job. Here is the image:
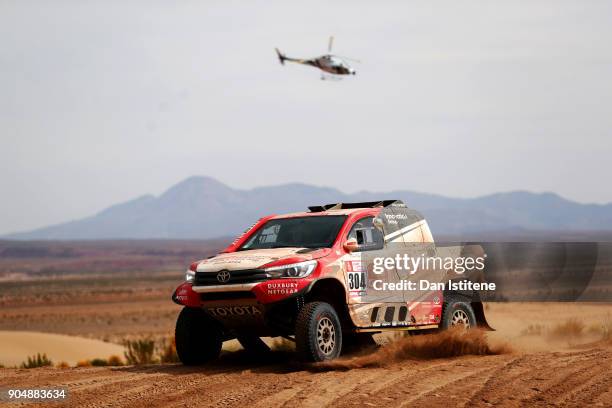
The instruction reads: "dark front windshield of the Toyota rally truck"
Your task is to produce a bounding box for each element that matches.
[238,215,346,251]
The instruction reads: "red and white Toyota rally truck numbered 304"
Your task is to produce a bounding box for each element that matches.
[172,200,489,365]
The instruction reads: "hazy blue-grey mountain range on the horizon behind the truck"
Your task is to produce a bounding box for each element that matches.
[5,177,612,240]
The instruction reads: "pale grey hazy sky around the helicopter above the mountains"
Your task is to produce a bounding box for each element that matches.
[0,0,612,233]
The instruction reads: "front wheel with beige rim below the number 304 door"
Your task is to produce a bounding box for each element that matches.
[295,302,342,361]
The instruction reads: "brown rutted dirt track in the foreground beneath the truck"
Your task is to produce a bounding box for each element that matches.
[0,348,612,407]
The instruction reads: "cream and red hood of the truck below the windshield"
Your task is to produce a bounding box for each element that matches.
[196,248,331,272]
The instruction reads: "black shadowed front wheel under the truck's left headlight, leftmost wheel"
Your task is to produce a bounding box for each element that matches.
[174,307,223,365]
